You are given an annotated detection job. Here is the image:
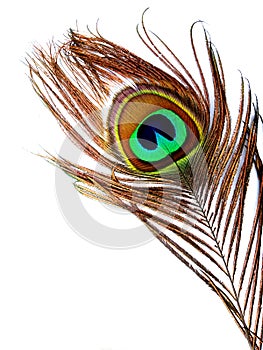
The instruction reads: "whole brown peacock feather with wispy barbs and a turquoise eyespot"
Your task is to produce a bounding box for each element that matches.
[28,13,263,350]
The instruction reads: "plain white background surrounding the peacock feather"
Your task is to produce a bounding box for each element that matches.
[0,0,263,350]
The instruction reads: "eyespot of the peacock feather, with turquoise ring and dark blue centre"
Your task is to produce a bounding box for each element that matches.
[109,86,203,173]
